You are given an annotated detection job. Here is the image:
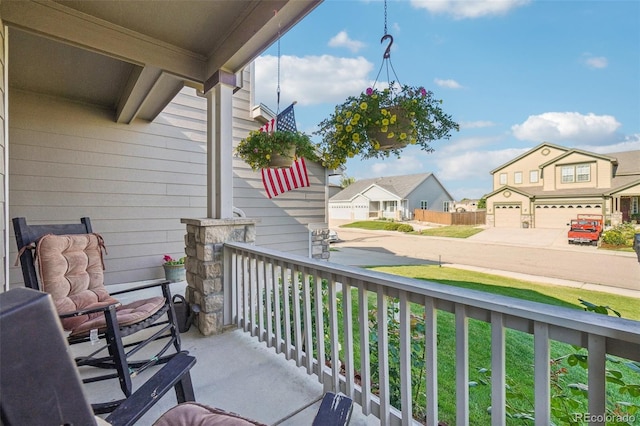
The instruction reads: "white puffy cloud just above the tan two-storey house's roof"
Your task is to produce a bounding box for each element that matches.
[511,112,620,145]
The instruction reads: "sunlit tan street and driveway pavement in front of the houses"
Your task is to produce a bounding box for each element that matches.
[330,228,640,295]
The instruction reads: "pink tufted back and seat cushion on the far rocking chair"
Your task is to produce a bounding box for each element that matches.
[36,234,165,335]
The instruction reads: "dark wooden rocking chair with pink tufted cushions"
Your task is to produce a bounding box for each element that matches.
[13,217,181,414]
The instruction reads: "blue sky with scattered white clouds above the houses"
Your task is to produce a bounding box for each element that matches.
[255,0,640,199]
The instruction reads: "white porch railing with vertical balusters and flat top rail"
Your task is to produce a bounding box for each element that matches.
[224,243,640,426]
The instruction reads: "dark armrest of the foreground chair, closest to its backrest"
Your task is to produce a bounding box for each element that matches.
[105,352,196,426]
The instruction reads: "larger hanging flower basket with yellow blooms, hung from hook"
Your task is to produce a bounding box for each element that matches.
[315,83,459,169]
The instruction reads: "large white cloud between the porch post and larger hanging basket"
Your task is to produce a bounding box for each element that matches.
[255,55,373,109]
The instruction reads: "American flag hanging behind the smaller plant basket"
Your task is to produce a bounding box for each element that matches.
[260,103,310,198]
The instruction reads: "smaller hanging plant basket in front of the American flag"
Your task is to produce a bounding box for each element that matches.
[236,130,318,170]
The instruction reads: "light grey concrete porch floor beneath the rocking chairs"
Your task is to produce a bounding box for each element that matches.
[88,283,380,426]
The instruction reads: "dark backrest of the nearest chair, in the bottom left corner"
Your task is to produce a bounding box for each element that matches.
[0,288,95,426]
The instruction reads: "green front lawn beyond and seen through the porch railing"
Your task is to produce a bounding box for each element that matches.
[322,265,640,425]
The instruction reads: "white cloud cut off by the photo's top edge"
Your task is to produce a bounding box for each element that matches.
[411,0,530,19]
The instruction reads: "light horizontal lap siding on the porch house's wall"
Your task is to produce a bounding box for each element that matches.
[10,66,325,286]
